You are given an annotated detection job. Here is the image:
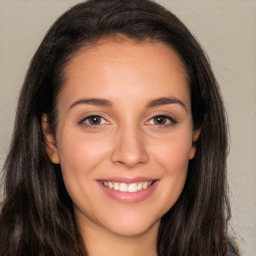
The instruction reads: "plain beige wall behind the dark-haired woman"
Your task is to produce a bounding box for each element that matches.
[0,0,256,256]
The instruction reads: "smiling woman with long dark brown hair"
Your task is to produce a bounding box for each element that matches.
[0,0,238,256]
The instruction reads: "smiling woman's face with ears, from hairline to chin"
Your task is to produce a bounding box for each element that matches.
[43,39,198,236]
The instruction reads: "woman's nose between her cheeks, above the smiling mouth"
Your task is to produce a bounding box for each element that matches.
[111,124,149,168]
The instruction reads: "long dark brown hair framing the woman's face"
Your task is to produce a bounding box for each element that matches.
[0,0,237,256]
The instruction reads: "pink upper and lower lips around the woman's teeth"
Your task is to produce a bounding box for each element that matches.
[98,177,159,203]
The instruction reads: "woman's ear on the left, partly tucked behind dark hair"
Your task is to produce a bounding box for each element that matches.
[41,114,60,164]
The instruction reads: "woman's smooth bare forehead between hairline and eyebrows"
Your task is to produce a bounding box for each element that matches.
[58,37,190,110]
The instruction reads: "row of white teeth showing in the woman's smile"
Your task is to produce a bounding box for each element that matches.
[102,181,156,193]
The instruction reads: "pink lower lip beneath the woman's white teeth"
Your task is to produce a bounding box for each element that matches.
[99,181,158,203]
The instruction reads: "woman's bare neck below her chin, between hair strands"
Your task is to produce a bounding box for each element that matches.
[79,218,159,256]
